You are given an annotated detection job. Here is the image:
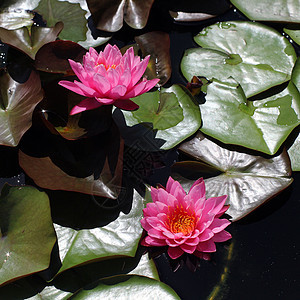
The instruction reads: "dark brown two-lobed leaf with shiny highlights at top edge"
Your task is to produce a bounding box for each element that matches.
[87,0,154,32]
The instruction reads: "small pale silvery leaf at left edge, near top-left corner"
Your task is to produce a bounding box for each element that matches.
[0,7,34,30]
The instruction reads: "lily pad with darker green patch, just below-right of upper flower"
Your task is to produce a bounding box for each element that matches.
[113,85,201,151]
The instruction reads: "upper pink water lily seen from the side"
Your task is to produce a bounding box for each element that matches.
[59,44,159,115]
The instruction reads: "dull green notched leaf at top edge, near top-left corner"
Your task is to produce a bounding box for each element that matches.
[34,0,87,42]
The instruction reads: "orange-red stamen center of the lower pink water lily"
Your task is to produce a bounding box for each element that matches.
[168,206,196,235]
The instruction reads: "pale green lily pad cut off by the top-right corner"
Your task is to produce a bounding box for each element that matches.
[230,0,300,23]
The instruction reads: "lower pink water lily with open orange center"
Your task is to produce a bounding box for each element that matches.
[141,177,231,259]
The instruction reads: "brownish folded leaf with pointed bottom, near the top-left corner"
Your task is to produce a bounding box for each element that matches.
[0,22,63,59]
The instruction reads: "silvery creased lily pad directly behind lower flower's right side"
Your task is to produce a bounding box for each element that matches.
[173,132,293,221]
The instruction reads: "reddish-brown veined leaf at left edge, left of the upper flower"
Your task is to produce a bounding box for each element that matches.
[0,71,43,146]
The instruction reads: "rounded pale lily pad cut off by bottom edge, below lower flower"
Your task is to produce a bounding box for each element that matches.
[70,275,180,300]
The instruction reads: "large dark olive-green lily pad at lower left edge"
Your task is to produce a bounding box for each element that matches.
[0,185,56,284]
